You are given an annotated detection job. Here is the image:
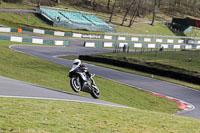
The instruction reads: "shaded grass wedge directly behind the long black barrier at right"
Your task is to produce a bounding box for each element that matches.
[94,51,200,72]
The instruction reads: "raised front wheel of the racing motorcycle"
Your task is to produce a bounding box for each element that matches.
[70,77,81,92]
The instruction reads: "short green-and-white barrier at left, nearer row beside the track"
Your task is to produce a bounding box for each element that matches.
[0,35,70,45]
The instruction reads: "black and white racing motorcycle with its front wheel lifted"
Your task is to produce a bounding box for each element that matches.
[69,65,100,99]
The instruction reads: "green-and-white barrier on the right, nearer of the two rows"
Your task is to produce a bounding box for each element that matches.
[84,42,200,49]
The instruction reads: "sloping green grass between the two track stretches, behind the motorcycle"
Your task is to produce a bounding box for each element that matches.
[0,41,179,113]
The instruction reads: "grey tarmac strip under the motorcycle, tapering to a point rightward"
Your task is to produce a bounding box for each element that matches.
[0,76,131,109]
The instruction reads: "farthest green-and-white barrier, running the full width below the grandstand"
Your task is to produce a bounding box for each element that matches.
[0,27,200,45]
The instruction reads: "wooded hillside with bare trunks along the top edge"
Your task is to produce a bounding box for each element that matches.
[0,0,200,27]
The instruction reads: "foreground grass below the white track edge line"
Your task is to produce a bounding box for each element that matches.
[0,98,200,133]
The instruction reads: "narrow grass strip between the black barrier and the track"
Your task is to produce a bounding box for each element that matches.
[60,56,200,90]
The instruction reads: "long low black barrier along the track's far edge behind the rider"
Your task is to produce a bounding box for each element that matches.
[79,55,200,85]
